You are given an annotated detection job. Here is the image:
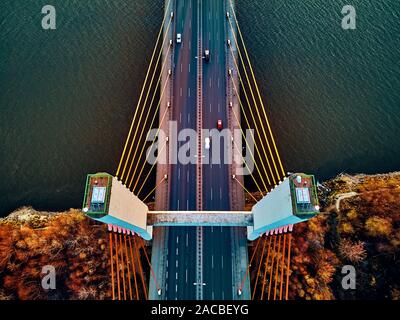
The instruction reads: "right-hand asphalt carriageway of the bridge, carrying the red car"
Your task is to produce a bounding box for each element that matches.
[202,0,232,300]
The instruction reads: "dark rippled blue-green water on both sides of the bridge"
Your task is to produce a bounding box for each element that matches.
[0,0,400,215]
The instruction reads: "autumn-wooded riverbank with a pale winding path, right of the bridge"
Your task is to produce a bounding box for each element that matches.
[247,172,400,300]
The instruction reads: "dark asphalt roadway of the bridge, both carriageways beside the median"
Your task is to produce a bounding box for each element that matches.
[165,0,232,300]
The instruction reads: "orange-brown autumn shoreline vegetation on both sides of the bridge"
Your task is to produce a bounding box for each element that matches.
[0,172,400,300]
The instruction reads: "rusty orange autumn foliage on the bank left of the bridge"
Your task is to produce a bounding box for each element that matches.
[0,210,111,300]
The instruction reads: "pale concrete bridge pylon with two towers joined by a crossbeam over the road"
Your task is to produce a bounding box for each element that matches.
[83,173,319,241]
